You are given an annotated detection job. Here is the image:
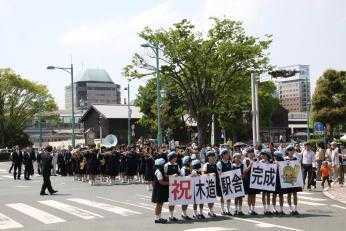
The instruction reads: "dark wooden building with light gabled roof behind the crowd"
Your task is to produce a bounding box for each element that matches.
[79,105,143,144]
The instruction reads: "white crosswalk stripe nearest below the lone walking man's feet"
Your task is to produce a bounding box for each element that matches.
[38,200,103,220]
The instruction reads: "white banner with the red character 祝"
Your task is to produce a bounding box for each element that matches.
[168,176,194,205]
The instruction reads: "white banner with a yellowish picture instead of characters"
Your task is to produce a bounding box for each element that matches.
[278,160,304,188]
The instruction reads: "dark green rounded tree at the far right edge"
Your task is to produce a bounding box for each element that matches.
[312,70,346,136]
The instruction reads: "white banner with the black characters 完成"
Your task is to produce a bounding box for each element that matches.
[250,162,277,191]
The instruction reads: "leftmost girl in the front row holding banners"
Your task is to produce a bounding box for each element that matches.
[151,158,169,224]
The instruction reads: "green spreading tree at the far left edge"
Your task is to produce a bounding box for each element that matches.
[0,69,57,146]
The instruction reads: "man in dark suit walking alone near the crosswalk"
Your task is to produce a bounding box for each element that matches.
[40,146,58,196]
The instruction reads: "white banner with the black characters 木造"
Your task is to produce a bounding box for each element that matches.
[191,175,217,204]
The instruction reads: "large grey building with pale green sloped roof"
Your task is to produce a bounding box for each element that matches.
[65,69,121,110]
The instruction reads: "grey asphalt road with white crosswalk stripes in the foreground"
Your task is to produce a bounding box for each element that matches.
[0,162,346,231]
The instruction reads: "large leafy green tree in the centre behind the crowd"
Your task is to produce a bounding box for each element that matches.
[125,18,271,144]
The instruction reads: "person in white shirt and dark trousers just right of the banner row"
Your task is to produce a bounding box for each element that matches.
[302,143,315,190]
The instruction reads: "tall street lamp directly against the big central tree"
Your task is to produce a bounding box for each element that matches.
[141,43,162,146]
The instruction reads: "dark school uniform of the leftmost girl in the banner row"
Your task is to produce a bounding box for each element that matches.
[151,168,169,203]
